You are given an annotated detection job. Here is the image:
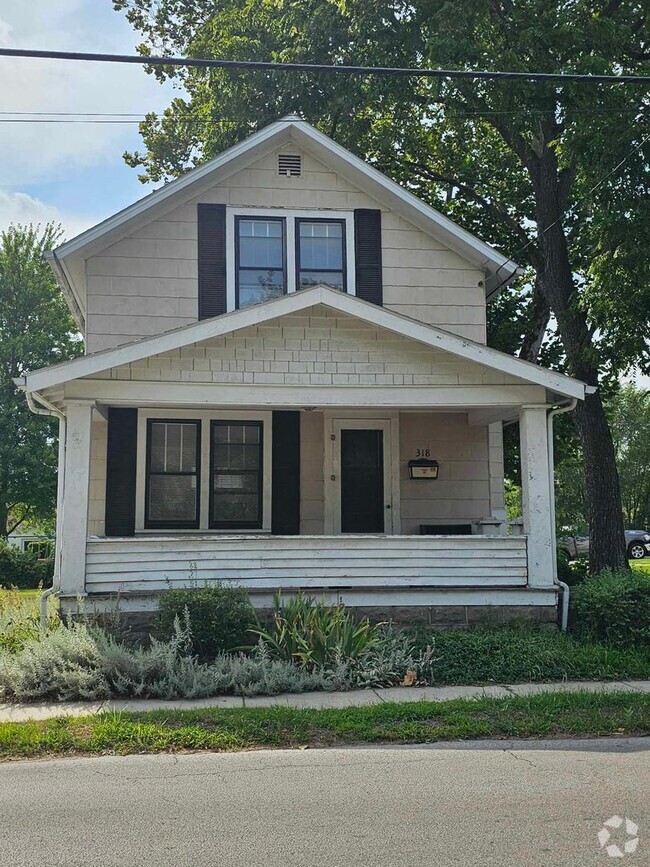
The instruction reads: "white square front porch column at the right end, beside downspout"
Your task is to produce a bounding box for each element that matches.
[519,406,555,587]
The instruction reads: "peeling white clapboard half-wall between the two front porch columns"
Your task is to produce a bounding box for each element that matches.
[86,536,527,593]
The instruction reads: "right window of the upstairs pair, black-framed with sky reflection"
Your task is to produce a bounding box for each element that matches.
[296,219,345,290]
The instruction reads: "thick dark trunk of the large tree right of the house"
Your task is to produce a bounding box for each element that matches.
[531,148,628,574]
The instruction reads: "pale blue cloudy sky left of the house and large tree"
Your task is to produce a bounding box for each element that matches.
[0,0,175,238]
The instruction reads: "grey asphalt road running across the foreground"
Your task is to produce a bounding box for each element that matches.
[0,739,650,867]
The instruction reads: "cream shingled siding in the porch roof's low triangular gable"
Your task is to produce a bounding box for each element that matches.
[96,306,520,385]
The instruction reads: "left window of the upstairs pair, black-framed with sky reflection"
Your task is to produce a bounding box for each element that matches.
[235,217,286,308]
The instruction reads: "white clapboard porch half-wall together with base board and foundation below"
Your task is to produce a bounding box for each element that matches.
[71,534,557,631]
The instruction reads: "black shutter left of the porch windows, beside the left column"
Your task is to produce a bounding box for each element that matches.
[106,407,138,536]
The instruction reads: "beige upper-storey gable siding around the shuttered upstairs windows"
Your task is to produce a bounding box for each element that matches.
[86,148,485,352]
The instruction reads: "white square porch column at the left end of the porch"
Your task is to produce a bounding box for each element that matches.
[61,401,94,596]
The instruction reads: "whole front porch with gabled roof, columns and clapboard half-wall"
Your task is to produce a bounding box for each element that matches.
[17,288,584,616]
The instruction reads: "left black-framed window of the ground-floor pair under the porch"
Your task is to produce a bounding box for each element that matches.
[145,419,201,529]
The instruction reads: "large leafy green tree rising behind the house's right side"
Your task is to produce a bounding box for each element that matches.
[114,0,650,571]
